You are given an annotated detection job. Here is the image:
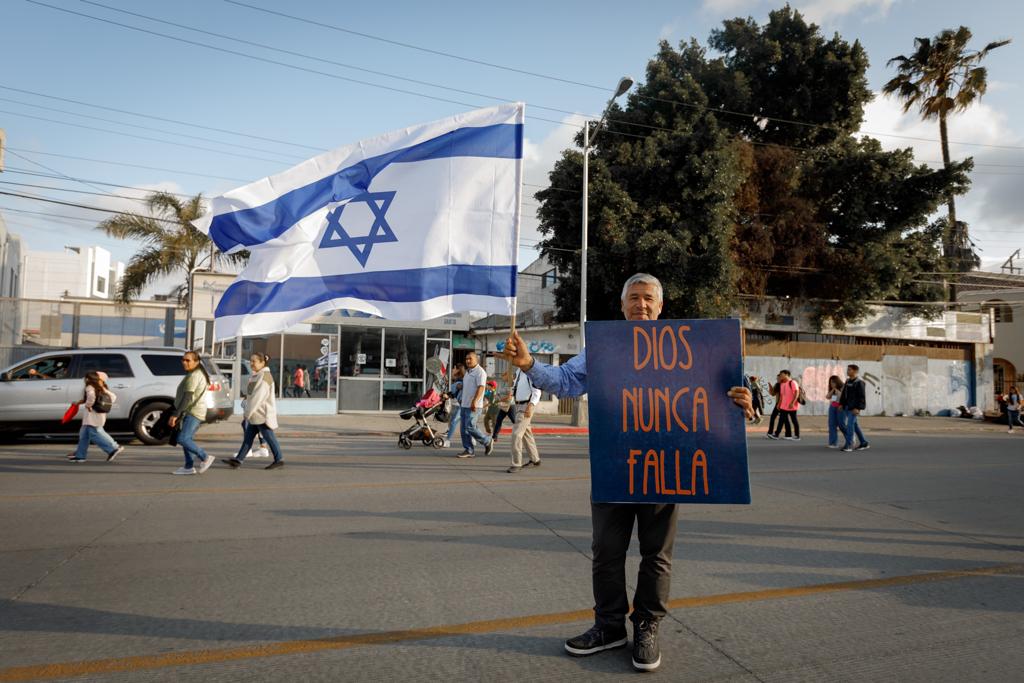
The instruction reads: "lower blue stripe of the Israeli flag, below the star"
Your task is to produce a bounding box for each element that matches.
[216,265,516,317]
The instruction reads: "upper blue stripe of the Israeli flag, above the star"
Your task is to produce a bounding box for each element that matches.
[210,123,522,252]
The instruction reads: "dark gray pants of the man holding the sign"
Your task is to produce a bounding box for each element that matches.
[591,503,678,628]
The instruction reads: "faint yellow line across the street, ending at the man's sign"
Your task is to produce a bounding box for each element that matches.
[0,476,590,503]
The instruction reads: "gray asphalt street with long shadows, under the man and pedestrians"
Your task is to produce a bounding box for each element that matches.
[0,424,1024,681]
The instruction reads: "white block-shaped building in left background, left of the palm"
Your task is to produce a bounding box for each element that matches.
[22,247,125,299]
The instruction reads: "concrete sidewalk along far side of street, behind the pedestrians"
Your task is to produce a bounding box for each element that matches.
[200,413,1024,438]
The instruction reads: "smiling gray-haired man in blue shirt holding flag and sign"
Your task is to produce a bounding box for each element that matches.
[505,273,754,671]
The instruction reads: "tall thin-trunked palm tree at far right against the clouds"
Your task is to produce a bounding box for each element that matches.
[882,26,1010,270]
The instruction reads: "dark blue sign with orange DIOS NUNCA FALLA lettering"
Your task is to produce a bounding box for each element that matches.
[586,319,751,504]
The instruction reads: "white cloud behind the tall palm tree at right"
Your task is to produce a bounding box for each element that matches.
[861,94,1024,266]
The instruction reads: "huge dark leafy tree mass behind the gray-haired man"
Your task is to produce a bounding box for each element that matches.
[537,7,971,327]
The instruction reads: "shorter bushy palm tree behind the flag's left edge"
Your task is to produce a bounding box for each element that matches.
[98,191,249,304]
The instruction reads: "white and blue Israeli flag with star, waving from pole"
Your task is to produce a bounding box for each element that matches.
[195,102,525,341]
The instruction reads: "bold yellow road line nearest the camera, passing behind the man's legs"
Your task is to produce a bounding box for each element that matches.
[0,564,1024,683]
